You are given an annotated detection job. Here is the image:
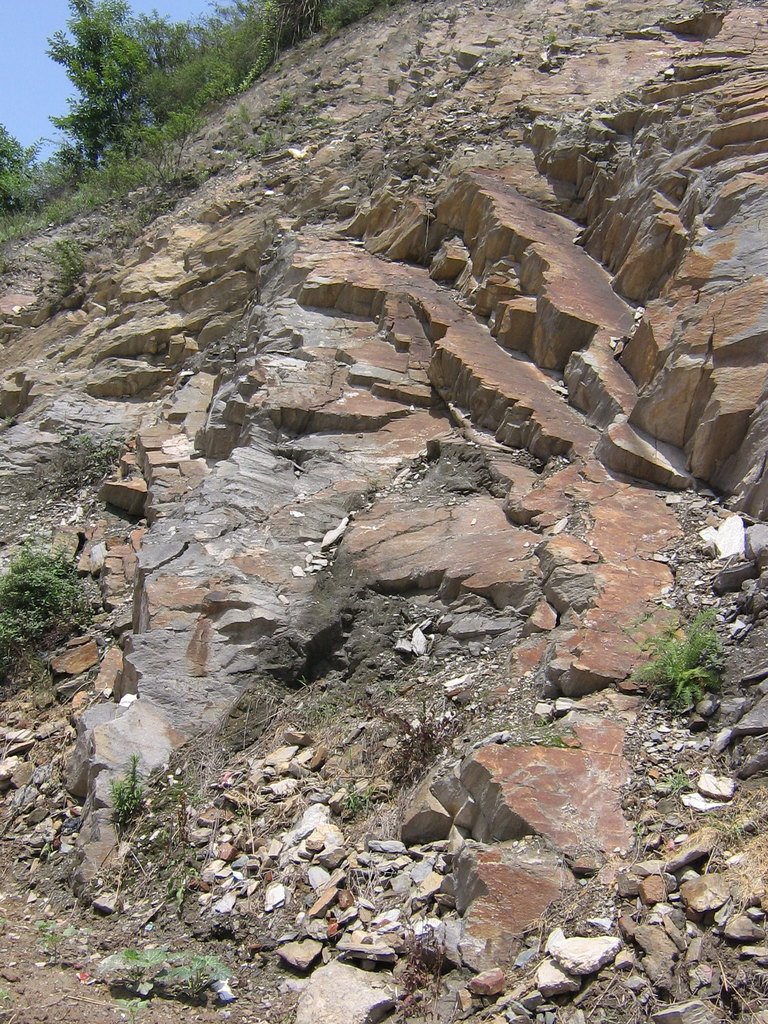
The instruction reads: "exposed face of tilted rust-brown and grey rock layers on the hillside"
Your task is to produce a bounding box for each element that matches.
[0,0,768,966]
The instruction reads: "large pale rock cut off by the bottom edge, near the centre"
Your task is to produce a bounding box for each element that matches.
[296,961,394,1024]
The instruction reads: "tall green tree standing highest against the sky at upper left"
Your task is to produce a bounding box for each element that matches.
[48,0,148,167]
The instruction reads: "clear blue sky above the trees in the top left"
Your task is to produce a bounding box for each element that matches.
[0,0,211,148]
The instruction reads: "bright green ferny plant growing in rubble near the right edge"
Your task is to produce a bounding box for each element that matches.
[634,611,723,709]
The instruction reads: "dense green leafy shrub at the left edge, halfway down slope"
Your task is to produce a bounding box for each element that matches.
[0,545,90,676]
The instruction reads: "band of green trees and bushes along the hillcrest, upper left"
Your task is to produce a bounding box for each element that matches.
[0,0,397,243]
